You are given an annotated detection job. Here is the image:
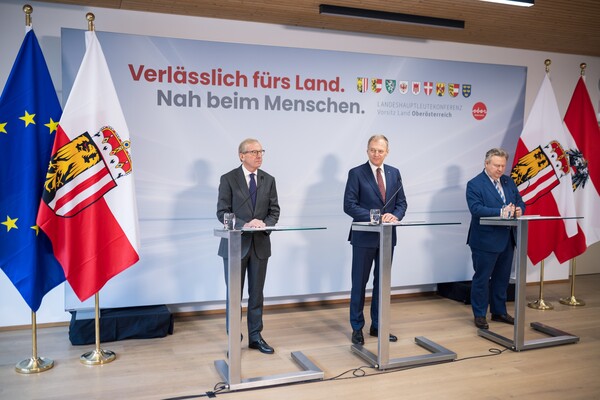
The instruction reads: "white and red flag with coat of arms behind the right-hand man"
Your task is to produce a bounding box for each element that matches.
[511,74,577,264]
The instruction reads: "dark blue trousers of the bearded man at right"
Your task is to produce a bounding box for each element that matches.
[471,240,514,317]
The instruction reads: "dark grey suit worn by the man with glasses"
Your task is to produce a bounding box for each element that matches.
[217,166,279,343]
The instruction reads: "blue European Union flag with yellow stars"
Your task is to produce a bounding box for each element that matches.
[0,30,65,312]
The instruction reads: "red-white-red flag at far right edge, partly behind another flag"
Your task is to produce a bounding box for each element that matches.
[555,77,600,259]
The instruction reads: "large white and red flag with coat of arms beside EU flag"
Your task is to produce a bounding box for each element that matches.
[37,31,139,301]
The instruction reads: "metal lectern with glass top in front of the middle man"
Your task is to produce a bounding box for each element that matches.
[351,221,460,370]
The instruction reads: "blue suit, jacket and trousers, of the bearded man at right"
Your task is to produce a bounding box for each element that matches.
[467,170,525,317]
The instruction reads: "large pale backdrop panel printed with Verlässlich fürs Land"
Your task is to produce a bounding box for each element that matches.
[61,29,526,309]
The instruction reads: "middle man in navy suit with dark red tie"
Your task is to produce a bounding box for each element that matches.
[344,135,407,344]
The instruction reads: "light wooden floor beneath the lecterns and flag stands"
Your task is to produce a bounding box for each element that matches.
[0,275,600,400]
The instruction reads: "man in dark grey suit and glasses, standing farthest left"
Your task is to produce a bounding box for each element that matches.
[217,139,279,354]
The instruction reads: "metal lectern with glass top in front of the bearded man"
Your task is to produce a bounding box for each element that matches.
[477,215,581,351]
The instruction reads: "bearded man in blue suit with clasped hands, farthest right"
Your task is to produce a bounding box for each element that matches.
[467,148,525,329]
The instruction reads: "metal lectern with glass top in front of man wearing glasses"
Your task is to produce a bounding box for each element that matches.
[214,227,325,390]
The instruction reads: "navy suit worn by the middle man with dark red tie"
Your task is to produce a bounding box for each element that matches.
[344,162,407,330]
